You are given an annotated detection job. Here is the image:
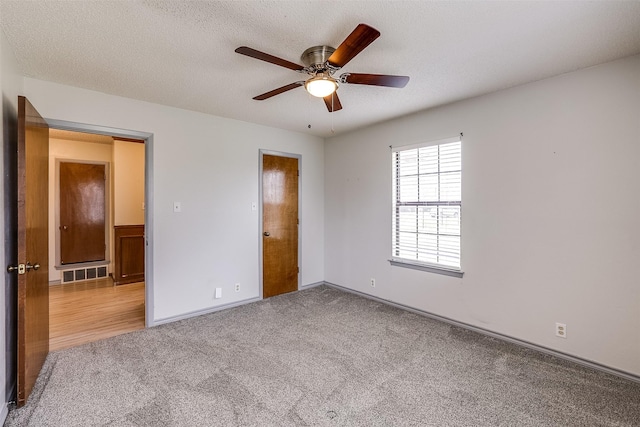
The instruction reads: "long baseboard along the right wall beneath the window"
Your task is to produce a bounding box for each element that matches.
[324,282,640,383]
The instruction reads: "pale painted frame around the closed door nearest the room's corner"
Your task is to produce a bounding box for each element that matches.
[258,149,302,299]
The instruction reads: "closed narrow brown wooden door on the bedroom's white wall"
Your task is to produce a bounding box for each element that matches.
[262,154,299,298]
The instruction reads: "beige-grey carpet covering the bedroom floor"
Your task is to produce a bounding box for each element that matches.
[5,286,640,426]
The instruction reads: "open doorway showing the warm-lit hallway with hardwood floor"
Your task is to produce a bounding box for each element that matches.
[49,128,146,350]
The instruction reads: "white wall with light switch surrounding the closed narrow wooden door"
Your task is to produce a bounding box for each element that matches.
[24,78,324,321]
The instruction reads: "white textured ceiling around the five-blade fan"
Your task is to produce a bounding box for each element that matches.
[0,0,640,137]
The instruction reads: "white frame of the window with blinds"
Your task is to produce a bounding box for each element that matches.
[389,134,464,278]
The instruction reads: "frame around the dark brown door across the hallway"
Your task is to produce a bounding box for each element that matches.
[55,157,113,270]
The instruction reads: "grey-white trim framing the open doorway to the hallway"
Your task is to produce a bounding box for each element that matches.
[45,117,155,328]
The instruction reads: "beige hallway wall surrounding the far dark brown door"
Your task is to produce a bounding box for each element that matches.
[47,139,113,282]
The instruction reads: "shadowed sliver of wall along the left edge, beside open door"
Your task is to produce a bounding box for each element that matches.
[0,30,23,424]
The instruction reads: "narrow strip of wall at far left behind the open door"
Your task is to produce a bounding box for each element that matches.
[0,30,23,424]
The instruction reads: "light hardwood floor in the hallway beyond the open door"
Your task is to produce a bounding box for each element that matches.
[49,278,144,351]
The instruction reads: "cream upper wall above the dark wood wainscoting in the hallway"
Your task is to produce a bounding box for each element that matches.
[113,140,144,225]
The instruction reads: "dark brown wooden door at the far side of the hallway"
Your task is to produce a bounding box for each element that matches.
[60,162,106,264]
